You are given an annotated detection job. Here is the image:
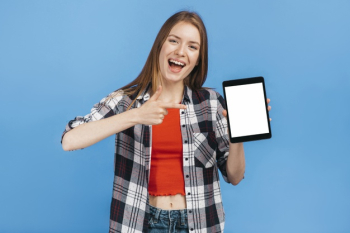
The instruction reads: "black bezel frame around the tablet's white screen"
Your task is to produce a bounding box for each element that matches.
[222,76,272,143]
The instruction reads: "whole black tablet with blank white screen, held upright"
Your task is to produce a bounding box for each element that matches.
[222,77,271,143]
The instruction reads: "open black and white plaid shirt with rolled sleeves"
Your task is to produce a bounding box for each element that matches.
[62,85,229,233]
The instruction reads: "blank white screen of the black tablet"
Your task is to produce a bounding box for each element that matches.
[225,83,269,137]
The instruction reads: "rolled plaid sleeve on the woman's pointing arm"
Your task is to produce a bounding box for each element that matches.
[61,91,123,143]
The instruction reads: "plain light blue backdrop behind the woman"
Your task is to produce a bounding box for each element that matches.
[0,0,350,233]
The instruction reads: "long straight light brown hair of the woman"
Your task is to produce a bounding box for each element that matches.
[110,11,208,109]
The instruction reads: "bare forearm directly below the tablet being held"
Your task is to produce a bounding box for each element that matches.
[226,143,245,185]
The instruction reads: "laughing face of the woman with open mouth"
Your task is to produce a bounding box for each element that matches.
[159,22,200,83]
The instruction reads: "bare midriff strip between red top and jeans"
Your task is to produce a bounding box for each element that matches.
[149,194,186,210]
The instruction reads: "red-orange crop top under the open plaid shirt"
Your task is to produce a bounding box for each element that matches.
[148,108,185,196]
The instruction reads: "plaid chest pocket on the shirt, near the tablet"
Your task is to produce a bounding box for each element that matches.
[193,131,217,168]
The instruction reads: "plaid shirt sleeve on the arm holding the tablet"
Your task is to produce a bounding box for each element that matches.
[215,93,230,183]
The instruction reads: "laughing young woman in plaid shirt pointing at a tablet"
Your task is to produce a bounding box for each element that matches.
[62,11,270,233]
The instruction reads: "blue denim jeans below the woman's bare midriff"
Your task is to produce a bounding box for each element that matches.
[148,205,188,233]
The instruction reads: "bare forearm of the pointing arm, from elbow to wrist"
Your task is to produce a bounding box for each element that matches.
[62,109,138,151]
